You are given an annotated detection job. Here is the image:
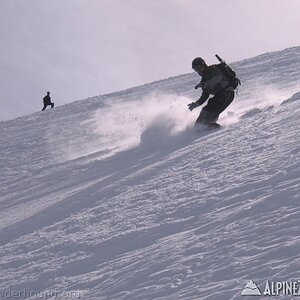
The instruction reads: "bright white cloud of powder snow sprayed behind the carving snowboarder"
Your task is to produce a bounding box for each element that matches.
[81,94,193,155]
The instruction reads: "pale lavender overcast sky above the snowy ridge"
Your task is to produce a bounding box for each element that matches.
[0,0,300,120]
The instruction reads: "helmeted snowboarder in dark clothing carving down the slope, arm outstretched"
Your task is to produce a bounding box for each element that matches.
[188,57,238,127]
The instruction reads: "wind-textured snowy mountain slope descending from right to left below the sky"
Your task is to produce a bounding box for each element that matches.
[0,47,300,300]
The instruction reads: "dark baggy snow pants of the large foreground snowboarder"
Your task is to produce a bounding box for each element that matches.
[196,91,234,124]
